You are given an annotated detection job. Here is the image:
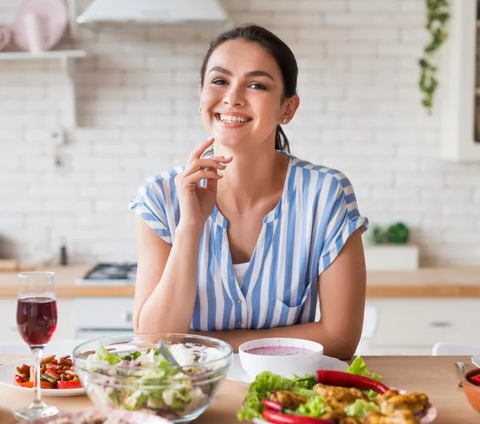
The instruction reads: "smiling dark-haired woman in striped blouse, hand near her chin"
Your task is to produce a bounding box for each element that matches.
[131,25,368,358]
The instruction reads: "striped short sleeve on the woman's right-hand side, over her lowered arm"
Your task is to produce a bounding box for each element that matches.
[318,172,368,275]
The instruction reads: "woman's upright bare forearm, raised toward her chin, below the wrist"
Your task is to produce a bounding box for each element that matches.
[136,226,201,333]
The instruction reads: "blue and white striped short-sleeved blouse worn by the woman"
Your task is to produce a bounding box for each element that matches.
[130,155,368,331]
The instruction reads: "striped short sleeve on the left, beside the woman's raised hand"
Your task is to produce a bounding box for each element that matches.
[128,178,172,245]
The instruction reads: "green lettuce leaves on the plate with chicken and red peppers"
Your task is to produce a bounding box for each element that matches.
[237,356,382,421]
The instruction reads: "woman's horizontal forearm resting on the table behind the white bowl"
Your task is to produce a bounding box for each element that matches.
[191,321,359,359]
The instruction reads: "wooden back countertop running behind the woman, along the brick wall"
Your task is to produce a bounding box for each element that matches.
[0,265,480,298]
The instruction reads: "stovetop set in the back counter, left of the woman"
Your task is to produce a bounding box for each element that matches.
[76,263,137,286]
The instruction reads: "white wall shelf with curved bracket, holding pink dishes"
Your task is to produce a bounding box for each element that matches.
[0,50,87,129]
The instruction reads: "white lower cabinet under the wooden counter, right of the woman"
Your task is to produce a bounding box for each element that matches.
[367,298,480,355]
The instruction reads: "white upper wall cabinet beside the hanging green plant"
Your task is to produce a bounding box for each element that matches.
[439,0,480,162]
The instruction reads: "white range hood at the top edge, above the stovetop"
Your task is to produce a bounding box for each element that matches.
[77,0,229,26]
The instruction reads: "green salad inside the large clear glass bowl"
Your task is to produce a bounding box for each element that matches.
[86,345,223,418]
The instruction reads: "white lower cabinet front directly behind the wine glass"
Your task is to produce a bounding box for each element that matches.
[0,298,74,343]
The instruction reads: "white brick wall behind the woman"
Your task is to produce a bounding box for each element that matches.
[0,0,480,265]
